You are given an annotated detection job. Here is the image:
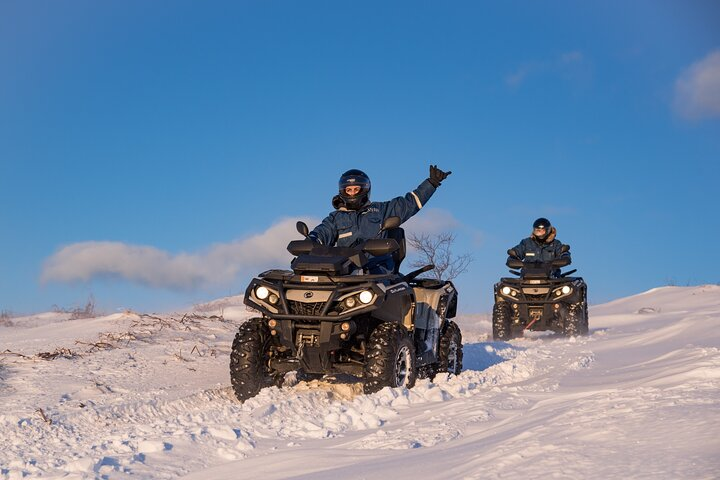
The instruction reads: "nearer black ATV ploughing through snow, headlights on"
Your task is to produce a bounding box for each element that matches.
[230,217,462,401]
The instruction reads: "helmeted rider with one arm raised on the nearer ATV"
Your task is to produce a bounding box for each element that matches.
[308,165,452,273]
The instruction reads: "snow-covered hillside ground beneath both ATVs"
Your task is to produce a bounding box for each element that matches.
[0,286,720,480]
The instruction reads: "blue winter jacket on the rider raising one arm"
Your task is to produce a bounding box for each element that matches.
[308,180,435,247]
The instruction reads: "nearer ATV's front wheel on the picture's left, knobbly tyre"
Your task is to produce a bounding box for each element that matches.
[230,318,283,402]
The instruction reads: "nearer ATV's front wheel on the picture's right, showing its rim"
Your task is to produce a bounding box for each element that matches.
[363,323,417,393]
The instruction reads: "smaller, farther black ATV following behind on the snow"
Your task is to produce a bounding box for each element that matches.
[492,245,588,340]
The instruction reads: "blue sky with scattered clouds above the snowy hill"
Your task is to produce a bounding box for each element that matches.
[0,0,720,314]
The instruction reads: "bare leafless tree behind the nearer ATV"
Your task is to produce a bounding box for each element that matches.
[408,233,474,280]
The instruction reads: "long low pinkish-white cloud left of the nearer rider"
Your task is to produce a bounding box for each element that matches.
[41,219,314,290]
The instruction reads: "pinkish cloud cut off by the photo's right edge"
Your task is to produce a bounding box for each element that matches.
[675,50,720,120]
